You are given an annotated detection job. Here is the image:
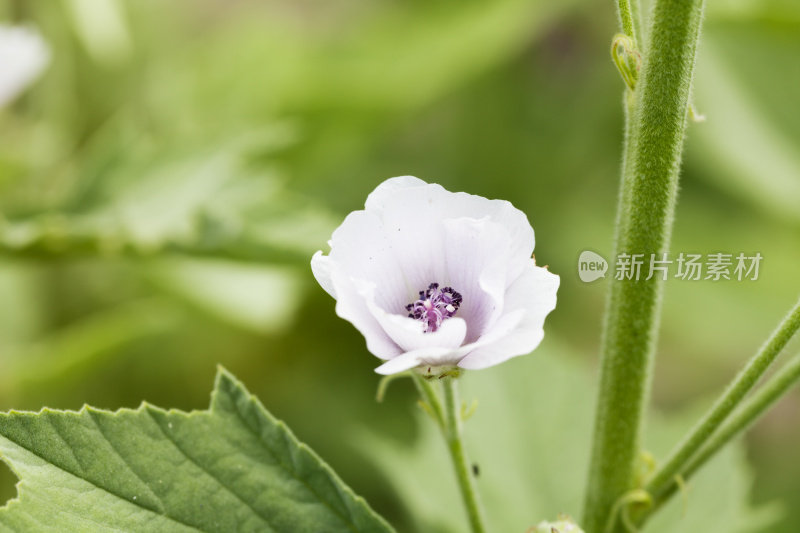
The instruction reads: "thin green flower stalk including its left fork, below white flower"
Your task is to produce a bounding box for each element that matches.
[413,373,486,533]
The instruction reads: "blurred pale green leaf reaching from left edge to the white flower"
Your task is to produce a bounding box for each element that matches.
[0,134,338,263]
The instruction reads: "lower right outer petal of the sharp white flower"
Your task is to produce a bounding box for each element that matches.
[458,261,561,369]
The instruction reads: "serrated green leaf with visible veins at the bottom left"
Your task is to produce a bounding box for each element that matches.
[0,370,392,533]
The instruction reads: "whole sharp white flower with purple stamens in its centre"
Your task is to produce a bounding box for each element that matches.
[311,176,560,374]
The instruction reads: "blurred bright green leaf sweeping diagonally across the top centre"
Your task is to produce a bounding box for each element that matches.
[191,0,574,115]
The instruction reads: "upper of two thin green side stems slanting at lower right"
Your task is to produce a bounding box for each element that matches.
[645,302,800,500]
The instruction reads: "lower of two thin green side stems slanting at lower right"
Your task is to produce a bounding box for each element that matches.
[639,354,800,524]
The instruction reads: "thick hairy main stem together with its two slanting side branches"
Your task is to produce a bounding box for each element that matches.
[583,0,800,533]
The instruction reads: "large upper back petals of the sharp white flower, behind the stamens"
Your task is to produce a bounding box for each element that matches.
[322,176,534,322]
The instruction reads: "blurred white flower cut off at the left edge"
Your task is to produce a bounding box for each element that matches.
[0,25,50,107]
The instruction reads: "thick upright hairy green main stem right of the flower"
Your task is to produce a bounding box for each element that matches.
[583,0,703,532]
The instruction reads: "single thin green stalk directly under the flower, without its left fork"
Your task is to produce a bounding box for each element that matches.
[442,377,486,533]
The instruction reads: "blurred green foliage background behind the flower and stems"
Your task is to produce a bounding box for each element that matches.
[0,0,800,533]
